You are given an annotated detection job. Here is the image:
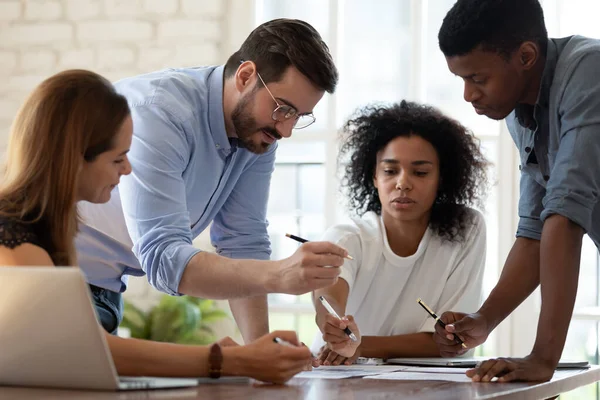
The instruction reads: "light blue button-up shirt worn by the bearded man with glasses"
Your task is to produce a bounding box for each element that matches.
[76,66,277,294]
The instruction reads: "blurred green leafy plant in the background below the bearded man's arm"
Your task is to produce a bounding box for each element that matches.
[120,295,228,344]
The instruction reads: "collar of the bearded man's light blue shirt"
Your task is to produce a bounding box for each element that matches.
[208,65,231,150]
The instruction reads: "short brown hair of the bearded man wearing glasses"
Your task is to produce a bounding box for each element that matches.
[225,18,338,93]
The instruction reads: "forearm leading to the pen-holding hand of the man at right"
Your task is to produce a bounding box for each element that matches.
[479,237,540,331]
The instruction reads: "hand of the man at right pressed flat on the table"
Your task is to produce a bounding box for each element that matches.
[467,354,557,382]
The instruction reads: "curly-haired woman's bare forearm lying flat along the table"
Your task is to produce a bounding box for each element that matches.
[359,332,440,359]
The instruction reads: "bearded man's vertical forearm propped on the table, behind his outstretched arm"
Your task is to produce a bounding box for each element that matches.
[229,295,269,343]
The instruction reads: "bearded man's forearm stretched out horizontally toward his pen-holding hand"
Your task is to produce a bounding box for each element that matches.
[178,251,274,299]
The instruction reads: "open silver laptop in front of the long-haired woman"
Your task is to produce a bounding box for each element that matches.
[0,267,199,390]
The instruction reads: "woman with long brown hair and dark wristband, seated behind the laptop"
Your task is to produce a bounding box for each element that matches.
[0,70,311,382]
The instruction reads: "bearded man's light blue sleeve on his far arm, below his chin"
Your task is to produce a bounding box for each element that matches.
[210,145,277,260]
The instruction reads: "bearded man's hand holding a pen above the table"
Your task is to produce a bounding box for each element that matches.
[267,242,348,295]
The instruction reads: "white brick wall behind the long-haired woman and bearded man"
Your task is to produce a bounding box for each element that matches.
[0,0,241,328]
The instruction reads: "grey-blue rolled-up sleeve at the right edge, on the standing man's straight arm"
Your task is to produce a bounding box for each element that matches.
[541,53,600,232]
